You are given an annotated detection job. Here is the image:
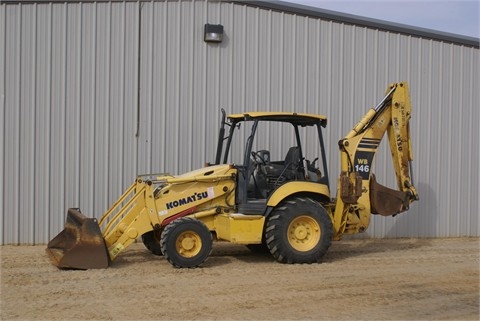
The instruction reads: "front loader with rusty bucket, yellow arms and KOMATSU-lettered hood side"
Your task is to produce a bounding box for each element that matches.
[46,164,236,269]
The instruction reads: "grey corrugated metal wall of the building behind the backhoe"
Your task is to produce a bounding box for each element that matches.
[0,1,480,244]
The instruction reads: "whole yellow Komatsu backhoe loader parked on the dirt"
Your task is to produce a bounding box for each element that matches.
[47,83,418,269]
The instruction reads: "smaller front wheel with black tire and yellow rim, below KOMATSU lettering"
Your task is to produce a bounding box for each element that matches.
[160,217,213,268]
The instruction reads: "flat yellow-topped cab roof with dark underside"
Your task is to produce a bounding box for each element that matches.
[228,111,327,127]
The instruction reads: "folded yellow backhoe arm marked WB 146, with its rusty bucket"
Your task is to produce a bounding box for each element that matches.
[333,82,418,239]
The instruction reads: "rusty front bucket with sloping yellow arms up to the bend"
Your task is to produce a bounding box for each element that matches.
[46,175,161,269]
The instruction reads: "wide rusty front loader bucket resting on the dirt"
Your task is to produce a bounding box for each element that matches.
[46,208,109,270]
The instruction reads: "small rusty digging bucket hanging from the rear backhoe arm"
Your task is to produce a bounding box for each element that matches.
[370,174,410,216]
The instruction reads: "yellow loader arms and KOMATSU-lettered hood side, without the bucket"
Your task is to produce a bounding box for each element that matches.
[99,169,234,261]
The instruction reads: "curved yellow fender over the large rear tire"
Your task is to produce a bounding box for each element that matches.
[267,181,330,207]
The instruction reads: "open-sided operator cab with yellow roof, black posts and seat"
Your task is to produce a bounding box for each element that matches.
[216,110,329,214]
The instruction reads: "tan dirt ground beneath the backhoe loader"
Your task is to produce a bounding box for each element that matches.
[0,238,479,320]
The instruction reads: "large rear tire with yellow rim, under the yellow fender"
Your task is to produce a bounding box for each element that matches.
[265,197,333,263]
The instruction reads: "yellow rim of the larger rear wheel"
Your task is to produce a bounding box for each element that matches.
[287,215,322,252]
